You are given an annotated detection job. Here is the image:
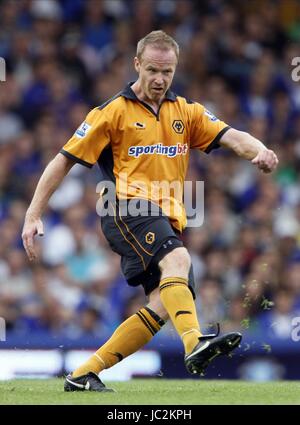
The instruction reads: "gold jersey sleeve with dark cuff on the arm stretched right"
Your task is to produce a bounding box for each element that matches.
[190,103,230,153]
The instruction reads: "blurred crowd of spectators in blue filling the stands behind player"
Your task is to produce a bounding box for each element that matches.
[0,0,300,340]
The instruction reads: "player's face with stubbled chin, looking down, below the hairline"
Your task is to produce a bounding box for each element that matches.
[134,45,177,102]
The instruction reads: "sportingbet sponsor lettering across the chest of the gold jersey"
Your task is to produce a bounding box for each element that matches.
[128,143,188,158]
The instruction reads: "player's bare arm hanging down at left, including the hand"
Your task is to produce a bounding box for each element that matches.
[22,153,75,261]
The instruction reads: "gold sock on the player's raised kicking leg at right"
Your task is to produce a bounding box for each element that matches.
[159,277,202,354]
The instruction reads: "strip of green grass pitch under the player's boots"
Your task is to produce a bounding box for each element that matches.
[0,378,300,405]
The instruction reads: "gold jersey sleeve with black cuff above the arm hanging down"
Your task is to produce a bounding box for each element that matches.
[60,108,110,168]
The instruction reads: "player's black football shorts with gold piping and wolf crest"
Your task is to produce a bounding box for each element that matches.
[101,200,195,298]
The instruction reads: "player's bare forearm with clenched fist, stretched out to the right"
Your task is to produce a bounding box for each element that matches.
[219,128,278,173]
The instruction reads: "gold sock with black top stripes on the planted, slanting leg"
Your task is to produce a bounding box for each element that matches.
[72,307,164,378]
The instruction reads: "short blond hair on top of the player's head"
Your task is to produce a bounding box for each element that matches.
[136,30,179,61]
